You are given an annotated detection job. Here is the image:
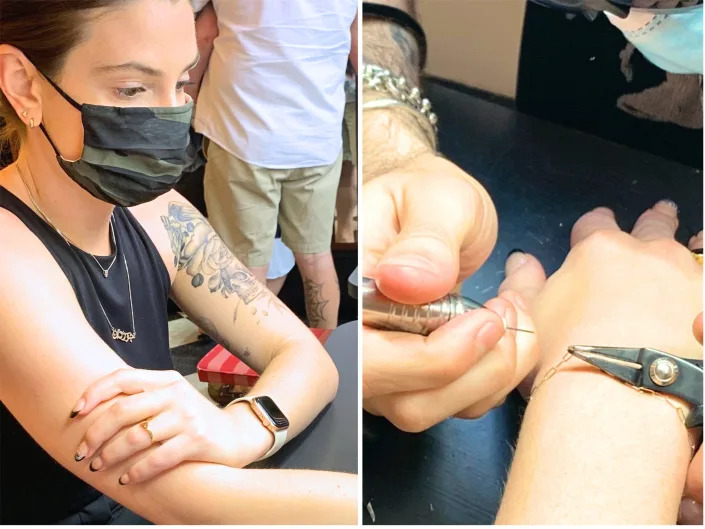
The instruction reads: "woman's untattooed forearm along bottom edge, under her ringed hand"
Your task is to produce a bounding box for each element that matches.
[124,463,358,525]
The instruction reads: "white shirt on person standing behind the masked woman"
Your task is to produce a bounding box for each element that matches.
[194,0,357,169]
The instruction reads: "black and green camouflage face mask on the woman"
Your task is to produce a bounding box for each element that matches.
[40,72,202,207]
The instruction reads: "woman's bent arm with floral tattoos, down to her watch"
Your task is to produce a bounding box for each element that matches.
[161,193,338,444]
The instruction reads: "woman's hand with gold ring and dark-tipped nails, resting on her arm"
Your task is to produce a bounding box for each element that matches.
[71,369,272,485]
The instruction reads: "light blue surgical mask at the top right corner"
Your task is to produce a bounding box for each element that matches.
[623,6,703,74]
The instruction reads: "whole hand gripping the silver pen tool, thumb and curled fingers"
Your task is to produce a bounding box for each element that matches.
[362,154,538,431]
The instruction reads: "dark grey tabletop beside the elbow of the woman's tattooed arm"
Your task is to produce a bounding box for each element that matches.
[251,321,359,474]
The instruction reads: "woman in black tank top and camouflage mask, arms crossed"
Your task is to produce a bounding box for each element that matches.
[0,0,357,523]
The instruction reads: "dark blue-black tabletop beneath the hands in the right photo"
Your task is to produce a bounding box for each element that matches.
[363,77,703,524]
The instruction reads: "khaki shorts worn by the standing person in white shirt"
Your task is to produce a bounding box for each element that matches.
[204,141,342,267]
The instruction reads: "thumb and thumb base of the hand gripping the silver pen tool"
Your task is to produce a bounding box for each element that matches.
[362,154,497,303]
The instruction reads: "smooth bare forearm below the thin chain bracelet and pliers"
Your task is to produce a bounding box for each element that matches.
[497,356,691,524]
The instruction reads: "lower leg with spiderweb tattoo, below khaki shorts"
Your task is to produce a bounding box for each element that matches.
[294,251,340,329]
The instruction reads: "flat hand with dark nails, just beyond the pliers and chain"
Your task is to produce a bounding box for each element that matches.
[500,201,702,371]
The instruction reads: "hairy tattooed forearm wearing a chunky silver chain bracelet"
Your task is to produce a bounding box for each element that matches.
[362,0,434,181]
